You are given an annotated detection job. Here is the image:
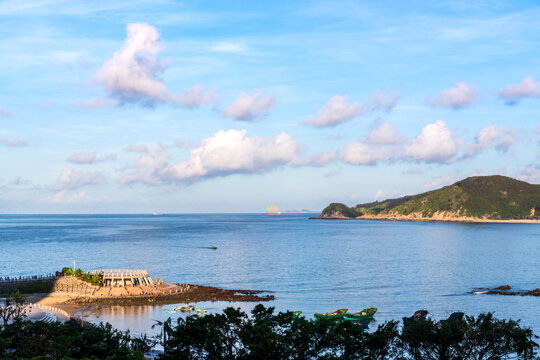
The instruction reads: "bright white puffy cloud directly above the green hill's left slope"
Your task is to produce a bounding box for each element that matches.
[403,120,463,163]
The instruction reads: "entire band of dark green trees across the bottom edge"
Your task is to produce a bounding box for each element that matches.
[0,304,539,360]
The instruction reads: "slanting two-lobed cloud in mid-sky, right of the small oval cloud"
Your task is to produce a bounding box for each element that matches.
[302,90,401,127]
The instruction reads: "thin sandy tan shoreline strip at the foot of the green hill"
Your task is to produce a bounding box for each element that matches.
[310,215,540,224]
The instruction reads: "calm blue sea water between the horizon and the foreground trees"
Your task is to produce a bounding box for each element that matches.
[0,214,540,335]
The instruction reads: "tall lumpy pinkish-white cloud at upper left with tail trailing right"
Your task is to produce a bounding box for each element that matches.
[96,23,217,108]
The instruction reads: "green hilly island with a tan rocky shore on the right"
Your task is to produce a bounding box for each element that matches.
[314,175,540,223]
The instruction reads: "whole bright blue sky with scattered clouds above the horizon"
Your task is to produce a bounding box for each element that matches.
[0,0,540,213]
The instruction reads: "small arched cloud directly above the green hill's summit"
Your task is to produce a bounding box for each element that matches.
[463,124,516,158]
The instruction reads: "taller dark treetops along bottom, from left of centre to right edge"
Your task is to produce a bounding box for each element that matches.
[154,305,538,360]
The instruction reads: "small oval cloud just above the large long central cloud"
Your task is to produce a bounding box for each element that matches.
[222,92,276,121]
